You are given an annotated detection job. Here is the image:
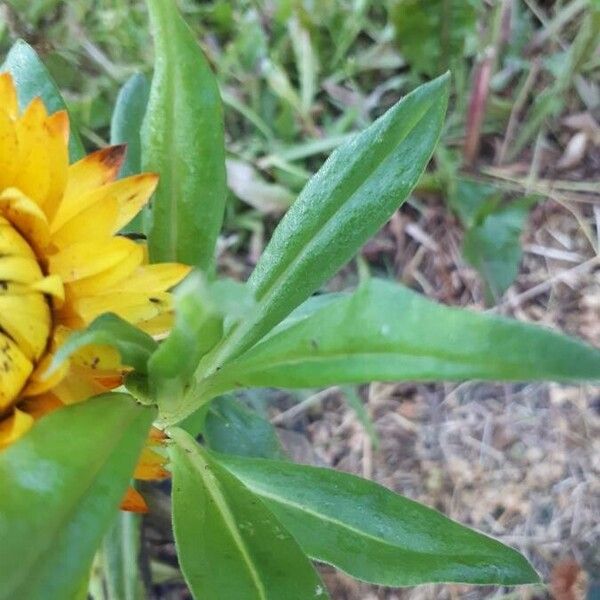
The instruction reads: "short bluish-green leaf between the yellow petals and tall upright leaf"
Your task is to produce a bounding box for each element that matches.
[110,73,150,177]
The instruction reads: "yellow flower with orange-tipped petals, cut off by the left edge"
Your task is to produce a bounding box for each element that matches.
[0,73,189,490]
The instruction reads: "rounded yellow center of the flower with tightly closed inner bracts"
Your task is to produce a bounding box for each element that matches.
[0,215,52,415]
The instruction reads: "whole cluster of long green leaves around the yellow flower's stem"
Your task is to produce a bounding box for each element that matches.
[0,0,600,599]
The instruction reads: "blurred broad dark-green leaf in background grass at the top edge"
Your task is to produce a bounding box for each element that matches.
[390,0,478,77]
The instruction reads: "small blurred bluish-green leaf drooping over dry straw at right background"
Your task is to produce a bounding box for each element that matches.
[463,196,535,304]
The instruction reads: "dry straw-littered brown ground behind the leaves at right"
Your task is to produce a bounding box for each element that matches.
[276,195,600,600]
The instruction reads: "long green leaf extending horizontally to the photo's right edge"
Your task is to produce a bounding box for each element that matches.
[197,279,600,398]
